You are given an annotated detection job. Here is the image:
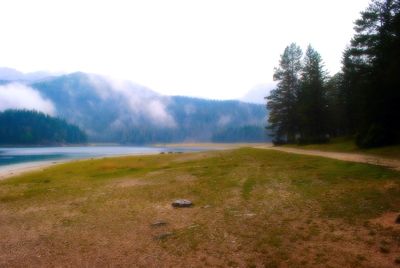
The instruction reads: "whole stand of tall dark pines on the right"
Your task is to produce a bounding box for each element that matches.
[266,0,400,148]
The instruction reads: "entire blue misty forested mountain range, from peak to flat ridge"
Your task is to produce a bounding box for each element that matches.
[0,72,266,144]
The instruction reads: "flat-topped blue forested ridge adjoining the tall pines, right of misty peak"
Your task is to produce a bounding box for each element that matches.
[167,97,267,142]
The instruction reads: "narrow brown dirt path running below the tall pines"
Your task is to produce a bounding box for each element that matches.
[255,145,400,171]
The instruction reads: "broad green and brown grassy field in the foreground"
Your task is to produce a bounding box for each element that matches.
[0,148,400,267]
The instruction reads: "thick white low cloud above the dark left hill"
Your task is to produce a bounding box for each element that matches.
[0,83,55,115]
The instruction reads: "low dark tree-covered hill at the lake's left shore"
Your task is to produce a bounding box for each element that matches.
[0,110,87,145]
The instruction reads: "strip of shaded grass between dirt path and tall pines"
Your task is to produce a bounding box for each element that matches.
[285,138,400,159]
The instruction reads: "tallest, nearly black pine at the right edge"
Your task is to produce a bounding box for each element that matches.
[344,0,400,147]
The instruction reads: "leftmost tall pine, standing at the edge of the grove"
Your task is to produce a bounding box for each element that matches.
[267,43,302,143]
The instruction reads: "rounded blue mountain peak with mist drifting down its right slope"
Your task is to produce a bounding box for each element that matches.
[31,72,173,143]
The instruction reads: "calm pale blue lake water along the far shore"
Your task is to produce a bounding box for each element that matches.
[0,146,202,167]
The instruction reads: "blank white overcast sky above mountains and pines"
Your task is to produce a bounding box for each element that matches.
[0,0,369,99]
